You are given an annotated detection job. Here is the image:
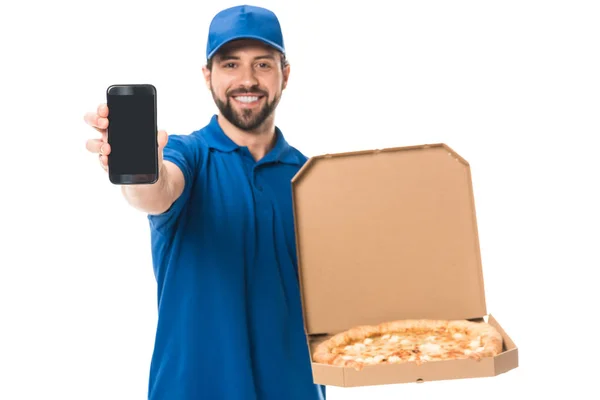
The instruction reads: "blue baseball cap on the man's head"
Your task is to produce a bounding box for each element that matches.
[206,5,285,60]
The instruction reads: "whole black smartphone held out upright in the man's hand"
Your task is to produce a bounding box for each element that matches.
[106,84,158,185]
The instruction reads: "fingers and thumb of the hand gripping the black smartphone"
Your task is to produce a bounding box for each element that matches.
[84,103,168,171]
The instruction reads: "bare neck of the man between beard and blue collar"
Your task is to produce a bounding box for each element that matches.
[218,113,275,161]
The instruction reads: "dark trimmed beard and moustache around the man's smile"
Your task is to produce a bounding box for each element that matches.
[210,87,281,131]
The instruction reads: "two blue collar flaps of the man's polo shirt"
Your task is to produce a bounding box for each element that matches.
[204,114,303,165]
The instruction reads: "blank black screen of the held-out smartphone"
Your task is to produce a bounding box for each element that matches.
[108,94,157,175]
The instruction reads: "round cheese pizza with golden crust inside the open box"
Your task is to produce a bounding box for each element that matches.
[313,319,503,371]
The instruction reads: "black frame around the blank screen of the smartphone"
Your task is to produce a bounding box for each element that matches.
[106,84,158,185]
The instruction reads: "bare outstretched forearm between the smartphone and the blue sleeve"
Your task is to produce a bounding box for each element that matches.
[121,163,173,214]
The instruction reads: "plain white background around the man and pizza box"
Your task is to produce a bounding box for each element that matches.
[0,0,600,400]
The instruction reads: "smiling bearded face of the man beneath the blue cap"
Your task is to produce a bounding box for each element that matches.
[204,40,289,131]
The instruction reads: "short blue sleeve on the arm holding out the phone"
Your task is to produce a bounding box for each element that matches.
[148,135,200,231]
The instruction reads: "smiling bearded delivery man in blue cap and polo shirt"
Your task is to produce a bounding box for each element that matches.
[86,6,325,400]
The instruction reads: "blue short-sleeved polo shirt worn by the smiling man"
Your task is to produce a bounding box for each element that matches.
[148,115,325,400]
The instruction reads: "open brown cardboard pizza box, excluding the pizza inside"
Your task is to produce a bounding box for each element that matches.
[292,144,518,387]
